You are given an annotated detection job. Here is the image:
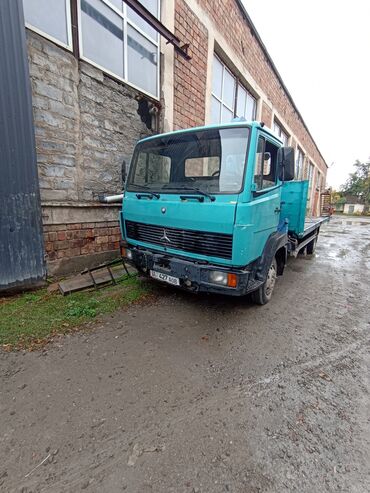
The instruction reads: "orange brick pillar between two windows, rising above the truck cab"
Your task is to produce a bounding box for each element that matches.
[174,0,208,129]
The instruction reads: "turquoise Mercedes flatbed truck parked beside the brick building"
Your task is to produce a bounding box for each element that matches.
[120,120,327,305]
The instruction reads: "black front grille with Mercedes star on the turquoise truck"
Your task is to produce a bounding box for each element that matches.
[125,221,233,259]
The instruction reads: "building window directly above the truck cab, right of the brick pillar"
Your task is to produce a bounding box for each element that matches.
[211,56,257,123]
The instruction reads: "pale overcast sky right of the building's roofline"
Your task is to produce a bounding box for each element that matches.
[243,0,370,190]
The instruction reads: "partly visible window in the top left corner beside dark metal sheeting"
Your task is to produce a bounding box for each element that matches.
[23,0,72,50]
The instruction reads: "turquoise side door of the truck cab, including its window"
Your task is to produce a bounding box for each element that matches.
[252,133,281,252]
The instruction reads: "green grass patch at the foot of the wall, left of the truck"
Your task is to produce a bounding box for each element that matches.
[0,277,150,350]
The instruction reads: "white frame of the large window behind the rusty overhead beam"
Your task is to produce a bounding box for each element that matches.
[77,0,161,101]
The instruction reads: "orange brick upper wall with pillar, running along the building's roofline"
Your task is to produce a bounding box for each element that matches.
[174,0,326,174]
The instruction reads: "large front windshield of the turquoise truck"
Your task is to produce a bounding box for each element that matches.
[127,127,249,193]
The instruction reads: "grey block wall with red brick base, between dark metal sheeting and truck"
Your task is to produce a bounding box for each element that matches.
[27,29,155,275]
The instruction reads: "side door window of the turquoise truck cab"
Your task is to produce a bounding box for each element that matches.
[254,137,278,190]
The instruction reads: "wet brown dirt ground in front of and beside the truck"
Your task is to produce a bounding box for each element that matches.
[0,218,370,493]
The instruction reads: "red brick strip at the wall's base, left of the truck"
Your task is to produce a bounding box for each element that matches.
[44,221,120,261]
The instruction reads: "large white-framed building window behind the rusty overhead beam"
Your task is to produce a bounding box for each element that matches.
[79,0,159,98]
